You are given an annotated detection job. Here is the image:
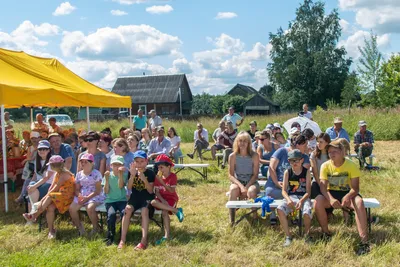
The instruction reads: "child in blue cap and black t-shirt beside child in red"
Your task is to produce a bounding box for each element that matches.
[118,150,155,250]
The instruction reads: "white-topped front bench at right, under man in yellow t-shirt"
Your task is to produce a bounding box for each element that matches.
[225,198,381,235]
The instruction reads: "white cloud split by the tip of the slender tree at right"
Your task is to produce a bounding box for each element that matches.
[338,31,390,59]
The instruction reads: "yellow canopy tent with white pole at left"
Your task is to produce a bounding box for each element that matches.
[0,48,131,211]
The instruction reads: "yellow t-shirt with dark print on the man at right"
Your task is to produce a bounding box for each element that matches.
[320,159,360,191]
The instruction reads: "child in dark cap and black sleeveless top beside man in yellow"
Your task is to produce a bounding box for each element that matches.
[277,149,312,247]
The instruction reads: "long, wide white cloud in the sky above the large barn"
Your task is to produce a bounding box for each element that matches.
[61,24,182,61]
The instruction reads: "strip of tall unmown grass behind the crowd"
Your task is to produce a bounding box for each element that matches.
[7,107,400,142]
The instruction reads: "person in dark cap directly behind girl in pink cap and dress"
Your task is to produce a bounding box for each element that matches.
[78,131,107,175]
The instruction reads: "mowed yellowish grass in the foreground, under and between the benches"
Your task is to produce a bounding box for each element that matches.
[0,141,400,266]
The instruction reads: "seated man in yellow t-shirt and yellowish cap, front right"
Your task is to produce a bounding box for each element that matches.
[314,140,369,255]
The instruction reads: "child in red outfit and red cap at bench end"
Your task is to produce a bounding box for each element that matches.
[151,154,184,245]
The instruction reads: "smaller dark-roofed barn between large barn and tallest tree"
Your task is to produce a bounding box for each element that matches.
[227,83,280,115]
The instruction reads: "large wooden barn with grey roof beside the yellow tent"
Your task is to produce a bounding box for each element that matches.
[112,74,193,115]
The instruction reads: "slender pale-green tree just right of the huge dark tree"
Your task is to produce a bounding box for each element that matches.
[357,31,383,93]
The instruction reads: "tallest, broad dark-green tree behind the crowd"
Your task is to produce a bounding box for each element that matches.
[268,0,352,109]
